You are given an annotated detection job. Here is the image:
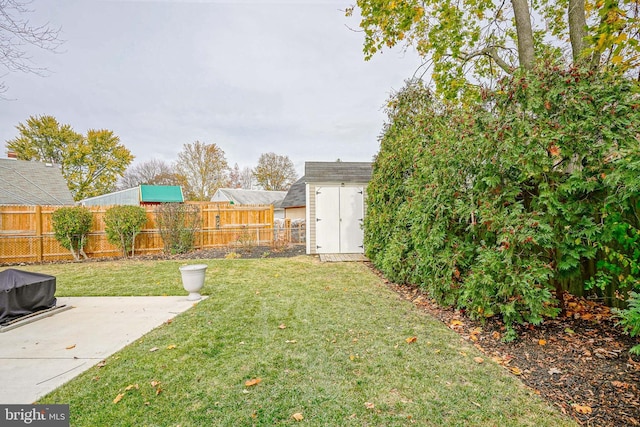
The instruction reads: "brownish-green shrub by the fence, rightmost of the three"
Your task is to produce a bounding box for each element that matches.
[156,203,199,254]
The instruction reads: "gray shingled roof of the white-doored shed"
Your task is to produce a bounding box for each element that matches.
[304,162,373,184]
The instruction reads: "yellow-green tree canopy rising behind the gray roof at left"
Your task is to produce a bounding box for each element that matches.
[7,116,133,200]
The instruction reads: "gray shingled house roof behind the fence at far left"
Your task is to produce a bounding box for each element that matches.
[0,159,74,205]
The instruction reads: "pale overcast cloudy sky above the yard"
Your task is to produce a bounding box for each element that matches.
[0,0,420,175]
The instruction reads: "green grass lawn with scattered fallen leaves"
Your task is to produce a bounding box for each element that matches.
[13,257,574,427]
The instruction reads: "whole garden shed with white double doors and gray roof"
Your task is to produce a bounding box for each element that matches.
[304,162,373,254]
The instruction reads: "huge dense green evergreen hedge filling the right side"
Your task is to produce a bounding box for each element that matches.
[365,65,640,338]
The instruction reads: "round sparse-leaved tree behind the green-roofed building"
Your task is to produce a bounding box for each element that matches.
[176,141,229,201]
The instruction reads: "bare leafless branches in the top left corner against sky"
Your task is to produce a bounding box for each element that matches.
[0,0,63,93]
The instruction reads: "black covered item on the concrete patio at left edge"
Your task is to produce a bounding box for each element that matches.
[0,268,56,324]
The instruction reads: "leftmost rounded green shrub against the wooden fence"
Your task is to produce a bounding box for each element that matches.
[52,206,93,260]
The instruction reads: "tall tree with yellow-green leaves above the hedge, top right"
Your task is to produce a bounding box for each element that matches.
[347,0,640,98]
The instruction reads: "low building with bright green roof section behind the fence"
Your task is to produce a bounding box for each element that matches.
[78,185,184,206]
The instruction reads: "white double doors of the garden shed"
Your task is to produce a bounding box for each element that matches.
[316,187,364,254]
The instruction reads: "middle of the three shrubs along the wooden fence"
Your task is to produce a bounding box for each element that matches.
[104,206,147,257]
